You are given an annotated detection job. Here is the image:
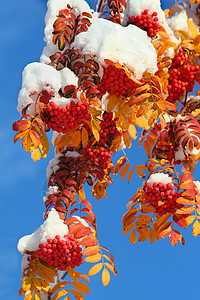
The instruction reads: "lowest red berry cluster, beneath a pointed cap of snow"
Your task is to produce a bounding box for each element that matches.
[36,235,83,271]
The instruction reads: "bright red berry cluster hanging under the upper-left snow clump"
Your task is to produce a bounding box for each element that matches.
[45,101,90,133]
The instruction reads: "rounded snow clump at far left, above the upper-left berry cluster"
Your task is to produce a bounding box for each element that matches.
[17,62,61,112]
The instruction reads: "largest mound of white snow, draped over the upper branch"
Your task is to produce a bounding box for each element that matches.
[72,19,157,79]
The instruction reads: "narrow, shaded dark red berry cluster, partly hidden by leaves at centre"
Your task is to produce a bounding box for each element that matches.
[98,112,122,145]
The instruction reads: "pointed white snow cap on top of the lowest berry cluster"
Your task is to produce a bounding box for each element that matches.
[17,209,68,254]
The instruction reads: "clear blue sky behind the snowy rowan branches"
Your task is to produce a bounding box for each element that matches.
[0,0,200,300]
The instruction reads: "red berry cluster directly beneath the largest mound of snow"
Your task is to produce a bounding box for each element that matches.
[99,65,139,98]
